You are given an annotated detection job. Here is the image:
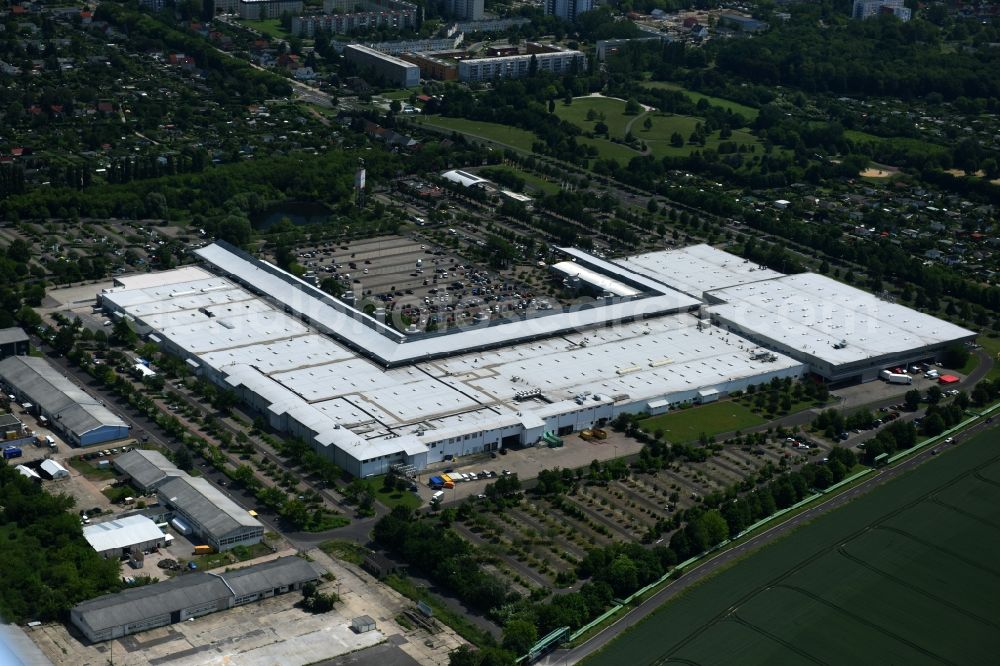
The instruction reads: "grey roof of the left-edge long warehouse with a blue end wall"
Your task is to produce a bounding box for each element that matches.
[0,356,127,437]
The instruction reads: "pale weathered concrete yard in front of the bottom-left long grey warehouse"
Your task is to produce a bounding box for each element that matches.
[30,550,463,666]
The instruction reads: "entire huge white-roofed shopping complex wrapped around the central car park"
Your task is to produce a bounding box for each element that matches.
[95,243,972,474]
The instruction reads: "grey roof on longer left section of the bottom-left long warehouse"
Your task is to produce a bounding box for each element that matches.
[73,573,231,632]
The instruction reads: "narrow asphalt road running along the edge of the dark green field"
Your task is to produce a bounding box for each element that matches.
[538,412,996,666]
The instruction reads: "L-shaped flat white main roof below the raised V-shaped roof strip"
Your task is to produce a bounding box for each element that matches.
[104,260,802,459]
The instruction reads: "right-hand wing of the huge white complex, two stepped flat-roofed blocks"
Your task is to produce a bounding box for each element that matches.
[617,245,976,385]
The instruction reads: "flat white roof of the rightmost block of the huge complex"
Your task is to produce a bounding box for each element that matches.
[709,273,975,365]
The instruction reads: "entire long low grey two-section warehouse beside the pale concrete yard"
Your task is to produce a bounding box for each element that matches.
[70,557,320,643]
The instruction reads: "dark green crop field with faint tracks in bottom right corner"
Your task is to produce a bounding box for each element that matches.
[585,430,1000,666]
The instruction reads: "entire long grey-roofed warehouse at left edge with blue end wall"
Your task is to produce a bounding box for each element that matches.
[0,356,129,446]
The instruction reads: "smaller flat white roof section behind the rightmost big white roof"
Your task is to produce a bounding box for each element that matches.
[614,244,783,298]
